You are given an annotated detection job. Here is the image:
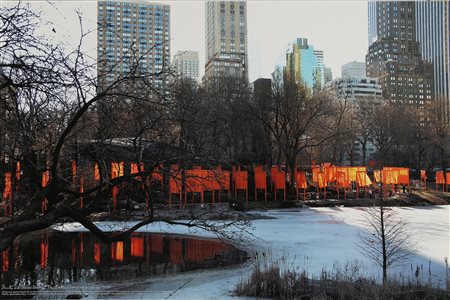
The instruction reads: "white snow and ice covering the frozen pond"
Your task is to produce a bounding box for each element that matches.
[47,206,450,299]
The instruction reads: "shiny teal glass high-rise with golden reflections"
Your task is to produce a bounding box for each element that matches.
[277,38,325,89]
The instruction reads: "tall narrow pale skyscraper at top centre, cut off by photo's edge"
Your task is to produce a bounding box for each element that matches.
[205,1,248,82]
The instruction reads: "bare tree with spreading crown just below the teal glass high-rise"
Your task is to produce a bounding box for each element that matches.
[248,70,339,191]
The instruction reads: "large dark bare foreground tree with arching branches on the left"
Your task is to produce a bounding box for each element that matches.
[0,3,248,250]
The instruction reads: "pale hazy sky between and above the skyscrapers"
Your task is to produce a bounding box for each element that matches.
[2,0,367,81]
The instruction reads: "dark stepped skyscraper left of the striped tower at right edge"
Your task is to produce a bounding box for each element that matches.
[366,1,433,106]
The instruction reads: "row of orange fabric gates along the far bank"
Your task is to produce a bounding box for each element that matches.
[3,161,450,215]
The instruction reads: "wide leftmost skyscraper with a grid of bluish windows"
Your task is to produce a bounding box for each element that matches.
[97,0,170,90]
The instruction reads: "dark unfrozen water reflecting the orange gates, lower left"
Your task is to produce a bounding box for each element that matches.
[1,232,246,287]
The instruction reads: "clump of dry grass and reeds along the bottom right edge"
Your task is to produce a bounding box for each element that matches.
[235,254,449,300]
